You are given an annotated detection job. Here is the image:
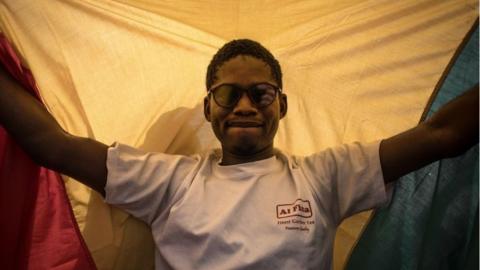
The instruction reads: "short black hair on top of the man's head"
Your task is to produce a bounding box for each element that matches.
[206,39,282,90]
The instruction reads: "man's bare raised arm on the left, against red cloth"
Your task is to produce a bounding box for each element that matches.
[0,67,108,195]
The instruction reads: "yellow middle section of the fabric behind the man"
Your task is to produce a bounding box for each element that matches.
[0,0,478,269]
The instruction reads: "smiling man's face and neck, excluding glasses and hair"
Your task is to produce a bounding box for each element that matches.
[204,55,287,165]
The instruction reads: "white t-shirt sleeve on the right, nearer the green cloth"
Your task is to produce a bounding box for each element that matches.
[302,141,389,224]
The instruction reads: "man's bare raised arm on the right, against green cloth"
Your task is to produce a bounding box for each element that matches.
[380,85,479,182]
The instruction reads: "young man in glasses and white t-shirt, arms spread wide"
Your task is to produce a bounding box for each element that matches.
[0,40,478,269]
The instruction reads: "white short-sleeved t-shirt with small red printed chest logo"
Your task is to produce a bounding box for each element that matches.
[105,142,387,270]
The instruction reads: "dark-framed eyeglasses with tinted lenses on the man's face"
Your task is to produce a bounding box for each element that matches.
[208,83,282,108]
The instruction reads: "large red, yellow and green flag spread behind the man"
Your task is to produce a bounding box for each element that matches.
[0,0,478,270]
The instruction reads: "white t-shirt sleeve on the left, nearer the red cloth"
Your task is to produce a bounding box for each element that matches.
[105,143,200,224]
